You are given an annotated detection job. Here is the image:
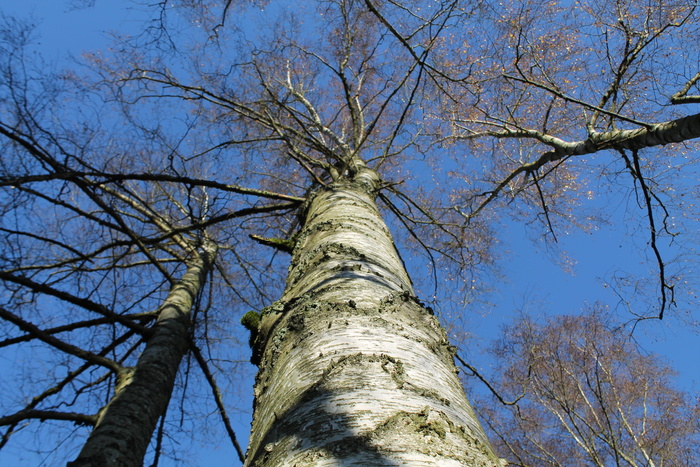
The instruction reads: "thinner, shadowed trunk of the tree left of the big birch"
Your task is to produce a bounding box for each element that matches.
[68,247,215,467]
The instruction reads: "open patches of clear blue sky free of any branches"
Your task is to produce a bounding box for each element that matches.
[0,0,700,466]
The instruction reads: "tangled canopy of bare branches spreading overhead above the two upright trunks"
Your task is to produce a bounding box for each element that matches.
[0,0,700,462]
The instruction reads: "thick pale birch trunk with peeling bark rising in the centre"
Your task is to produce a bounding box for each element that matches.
[246,168,501,466]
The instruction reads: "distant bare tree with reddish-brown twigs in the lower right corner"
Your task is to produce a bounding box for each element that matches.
[480,307,700,466]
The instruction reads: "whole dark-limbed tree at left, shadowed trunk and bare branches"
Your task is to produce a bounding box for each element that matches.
[0,15,290,465]
